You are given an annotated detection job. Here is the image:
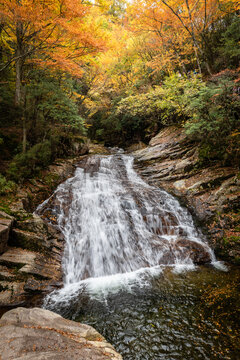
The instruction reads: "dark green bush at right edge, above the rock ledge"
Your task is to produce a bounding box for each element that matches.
[185,71,240,165]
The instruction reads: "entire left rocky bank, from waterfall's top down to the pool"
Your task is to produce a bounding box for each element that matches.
[0,144,111,311]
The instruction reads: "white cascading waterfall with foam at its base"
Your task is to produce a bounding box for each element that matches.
[39,154,223,304]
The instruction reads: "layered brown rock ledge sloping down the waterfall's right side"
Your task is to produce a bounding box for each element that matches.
[133,127,240,264]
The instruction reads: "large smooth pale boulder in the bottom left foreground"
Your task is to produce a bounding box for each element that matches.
[0,308,122,360]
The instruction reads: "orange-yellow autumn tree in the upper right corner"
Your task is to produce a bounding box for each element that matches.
[129,0,239,74]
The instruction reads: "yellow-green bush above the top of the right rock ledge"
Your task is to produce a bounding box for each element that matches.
[96,74,204,143]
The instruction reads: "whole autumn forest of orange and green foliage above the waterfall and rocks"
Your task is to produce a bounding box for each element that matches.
[0,0,240,186]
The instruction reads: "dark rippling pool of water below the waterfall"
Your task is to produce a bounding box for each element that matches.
[51,267,240,360]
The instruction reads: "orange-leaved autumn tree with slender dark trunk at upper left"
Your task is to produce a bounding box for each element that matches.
[0,0,105,151]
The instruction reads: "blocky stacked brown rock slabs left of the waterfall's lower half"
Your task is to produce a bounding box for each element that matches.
[0,215,64,306]
